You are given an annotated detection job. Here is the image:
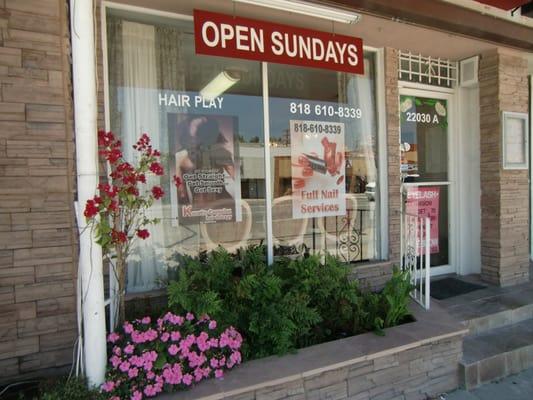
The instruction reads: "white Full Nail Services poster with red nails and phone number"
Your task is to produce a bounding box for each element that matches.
[290,120,346,218]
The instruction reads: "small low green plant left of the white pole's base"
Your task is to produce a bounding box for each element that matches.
[39,378,106,400]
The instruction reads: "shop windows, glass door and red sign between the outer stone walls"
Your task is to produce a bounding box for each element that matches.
[96,2,532,293]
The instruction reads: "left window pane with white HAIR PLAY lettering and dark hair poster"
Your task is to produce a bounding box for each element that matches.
[107,10,265,292]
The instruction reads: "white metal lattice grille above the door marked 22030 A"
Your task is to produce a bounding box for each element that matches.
[398,51,458,88]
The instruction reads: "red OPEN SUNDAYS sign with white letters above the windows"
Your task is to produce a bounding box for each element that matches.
[194,10,364,74]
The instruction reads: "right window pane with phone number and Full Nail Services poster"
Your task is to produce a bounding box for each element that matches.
[268,55,379,262]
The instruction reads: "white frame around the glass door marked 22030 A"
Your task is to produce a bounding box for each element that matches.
[398,81,459,276]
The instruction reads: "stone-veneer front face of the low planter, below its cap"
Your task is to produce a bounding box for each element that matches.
[162,335,462,400]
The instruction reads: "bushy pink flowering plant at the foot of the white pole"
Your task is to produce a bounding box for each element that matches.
[102,312,242,400]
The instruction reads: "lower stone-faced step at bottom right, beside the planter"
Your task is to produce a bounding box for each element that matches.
[460,318,533,390]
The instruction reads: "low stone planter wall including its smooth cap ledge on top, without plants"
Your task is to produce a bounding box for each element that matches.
[158,303,468,400]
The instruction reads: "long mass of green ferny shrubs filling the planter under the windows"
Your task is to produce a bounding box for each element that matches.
[168,246,411,359]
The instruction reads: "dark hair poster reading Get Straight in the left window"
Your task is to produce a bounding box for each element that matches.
[168,113,241,225]
